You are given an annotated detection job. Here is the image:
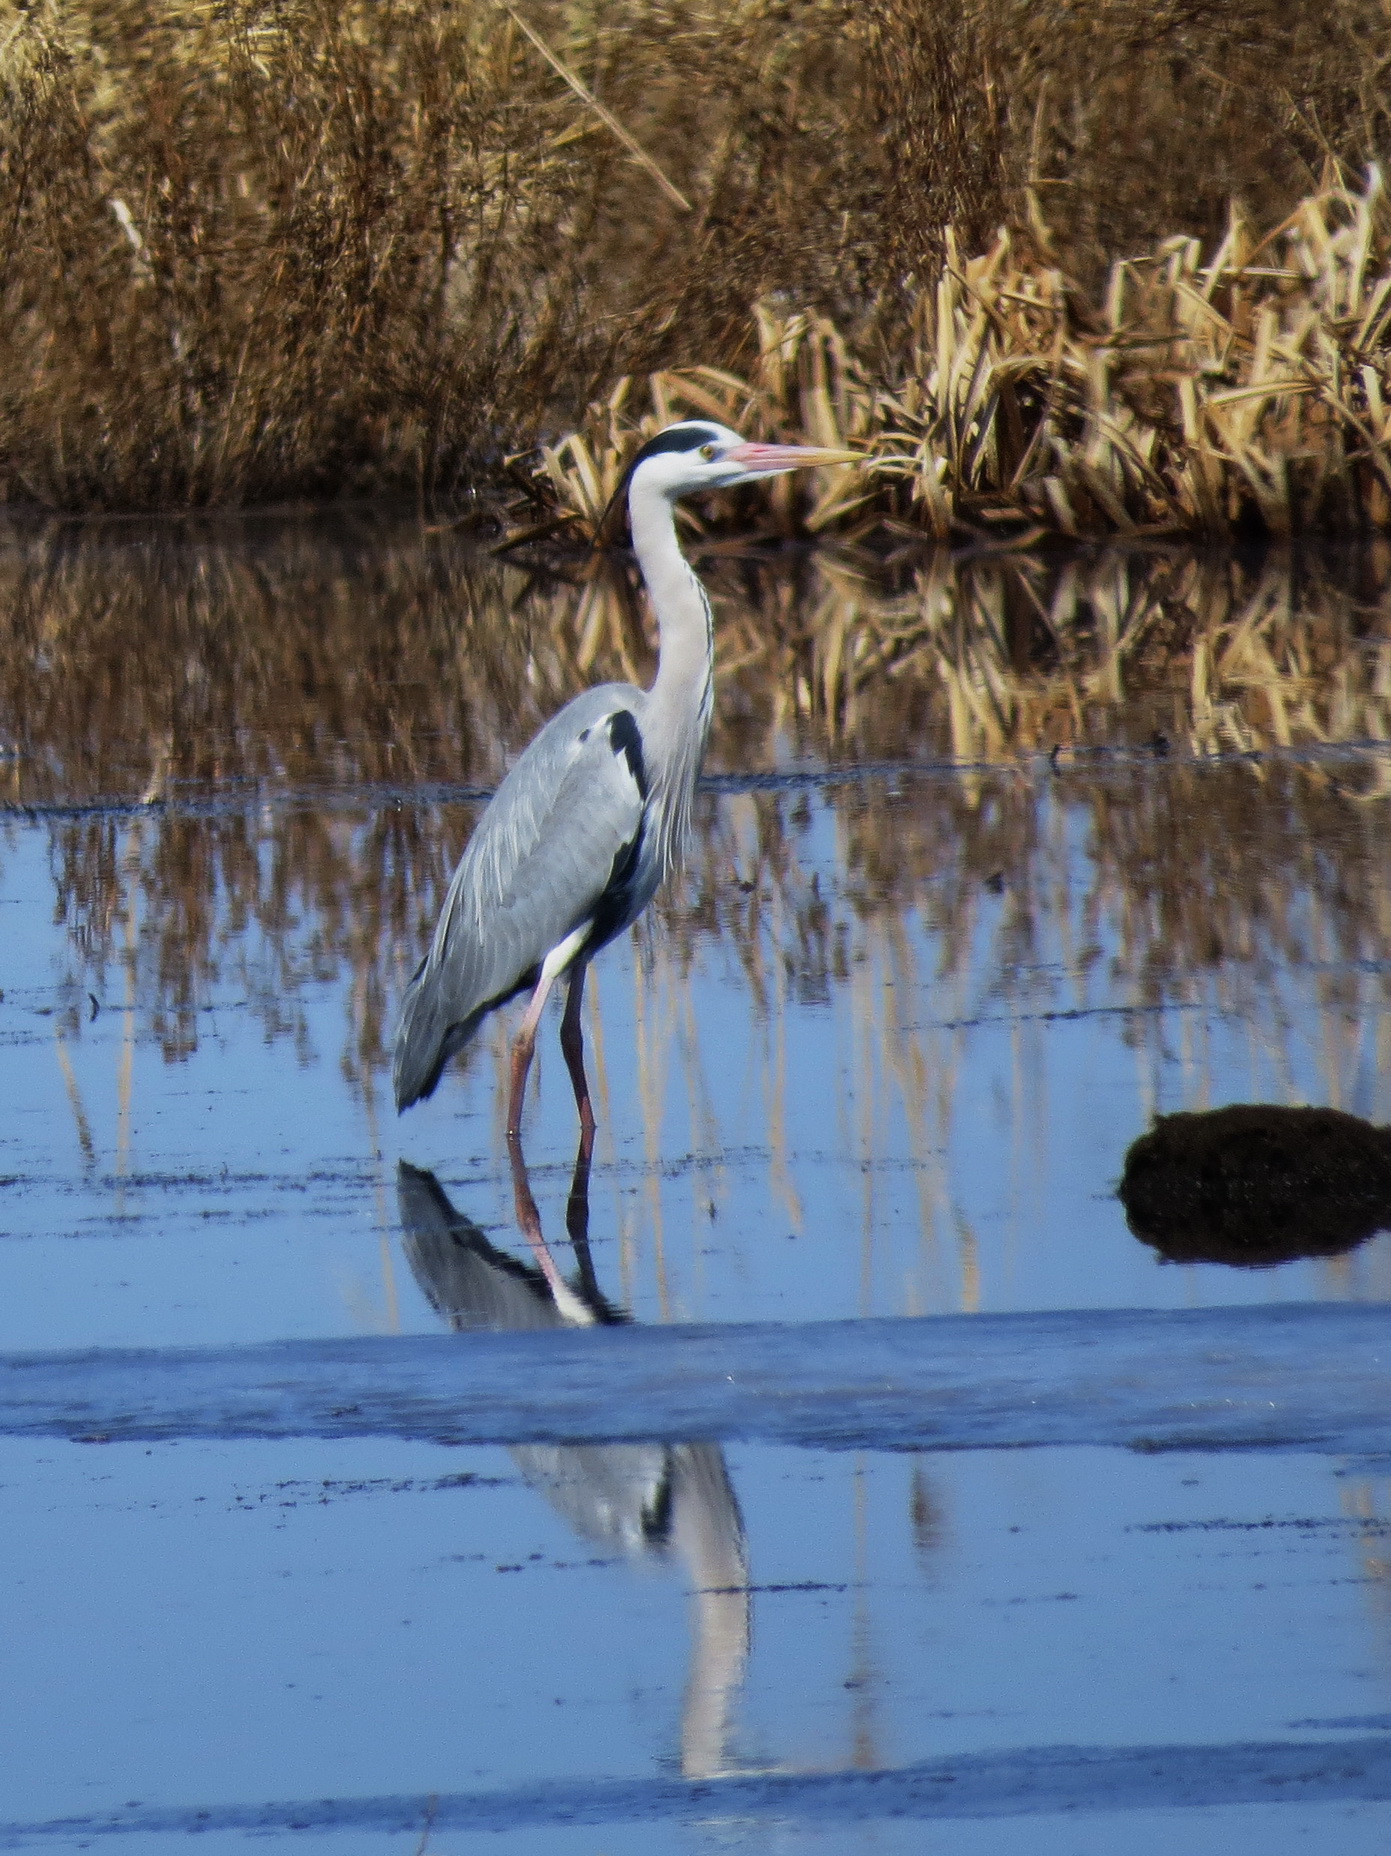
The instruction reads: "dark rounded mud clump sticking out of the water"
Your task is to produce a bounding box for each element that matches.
[1118,1104,1391,1270]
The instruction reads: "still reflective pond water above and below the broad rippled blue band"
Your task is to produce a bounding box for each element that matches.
[0,523,1391,1856]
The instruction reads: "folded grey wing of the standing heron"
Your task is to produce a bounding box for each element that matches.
[394,683,644,1108]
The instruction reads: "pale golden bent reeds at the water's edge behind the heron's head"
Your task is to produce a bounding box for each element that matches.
[537,167,1391,538]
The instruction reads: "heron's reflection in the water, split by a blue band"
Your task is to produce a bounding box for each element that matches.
[397,1140,748,1778]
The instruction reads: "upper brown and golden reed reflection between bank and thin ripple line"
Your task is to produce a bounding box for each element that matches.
[0,516,1391,811]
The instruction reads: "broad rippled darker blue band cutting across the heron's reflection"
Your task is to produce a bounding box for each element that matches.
[0,1306,1391,1453]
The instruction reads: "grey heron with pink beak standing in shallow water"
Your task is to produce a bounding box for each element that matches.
[392,419,860,1140]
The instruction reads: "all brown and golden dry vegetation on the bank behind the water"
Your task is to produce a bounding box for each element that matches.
[0,0,1391,535]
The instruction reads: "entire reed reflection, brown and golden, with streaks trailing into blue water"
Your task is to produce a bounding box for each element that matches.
[0,520,1391,1307]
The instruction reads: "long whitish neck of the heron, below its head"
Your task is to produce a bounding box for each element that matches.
[628,483,715,874]
